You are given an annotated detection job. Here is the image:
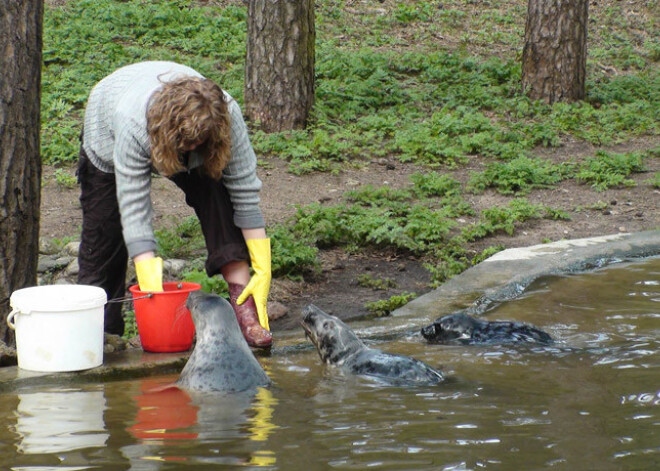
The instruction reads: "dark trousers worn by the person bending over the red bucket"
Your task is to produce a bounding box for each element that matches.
[77,146,249,335]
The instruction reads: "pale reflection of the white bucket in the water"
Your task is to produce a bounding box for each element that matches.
[15,389,109,454]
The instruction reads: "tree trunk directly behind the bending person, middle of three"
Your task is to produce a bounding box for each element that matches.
[245,0,316,132]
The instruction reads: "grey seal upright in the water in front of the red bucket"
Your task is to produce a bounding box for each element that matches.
[176,291,270,392]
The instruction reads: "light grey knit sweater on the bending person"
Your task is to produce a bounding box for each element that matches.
[83,62,265,257]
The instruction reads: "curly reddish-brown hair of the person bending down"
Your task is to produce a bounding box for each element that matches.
[147,77,231,180]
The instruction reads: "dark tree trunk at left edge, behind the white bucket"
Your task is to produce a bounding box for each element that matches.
[0,0,43,343]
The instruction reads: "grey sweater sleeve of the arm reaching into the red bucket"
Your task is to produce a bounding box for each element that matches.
[113,120,156,258]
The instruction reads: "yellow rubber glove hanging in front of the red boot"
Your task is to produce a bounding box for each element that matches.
[236,238,272,330]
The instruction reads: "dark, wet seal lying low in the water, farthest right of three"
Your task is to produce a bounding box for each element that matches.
[422,312,553,345]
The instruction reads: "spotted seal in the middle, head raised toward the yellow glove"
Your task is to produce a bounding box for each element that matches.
[301,304,444,385]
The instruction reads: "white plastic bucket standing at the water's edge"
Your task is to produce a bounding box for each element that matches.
[7,285,107,372]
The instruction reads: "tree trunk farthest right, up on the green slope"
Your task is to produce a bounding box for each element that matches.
[522,0,589,104]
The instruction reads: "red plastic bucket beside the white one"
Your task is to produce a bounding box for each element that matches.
[128,281,202,352]
